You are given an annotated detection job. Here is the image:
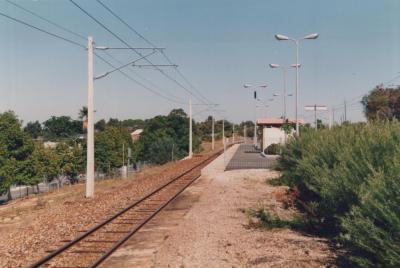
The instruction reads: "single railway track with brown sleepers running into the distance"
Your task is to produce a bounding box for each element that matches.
[29,150,223,267]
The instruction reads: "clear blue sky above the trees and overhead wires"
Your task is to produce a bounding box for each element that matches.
[0,0,400,122]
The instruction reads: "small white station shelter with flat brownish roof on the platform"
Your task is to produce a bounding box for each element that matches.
[257,118,304,151]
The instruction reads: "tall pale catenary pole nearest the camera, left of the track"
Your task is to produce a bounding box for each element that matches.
[85,36,94,198]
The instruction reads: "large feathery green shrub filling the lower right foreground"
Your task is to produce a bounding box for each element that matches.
[278,122,400,267]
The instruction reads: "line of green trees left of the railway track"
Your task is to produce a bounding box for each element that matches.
[0,107,253,199]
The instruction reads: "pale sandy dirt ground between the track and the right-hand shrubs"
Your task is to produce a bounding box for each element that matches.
[104,143,335,267]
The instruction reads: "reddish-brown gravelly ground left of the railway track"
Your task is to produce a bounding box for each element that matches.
[0,142,222,267]
